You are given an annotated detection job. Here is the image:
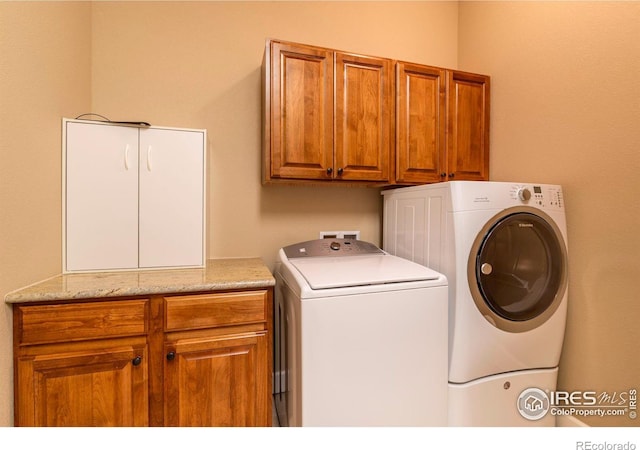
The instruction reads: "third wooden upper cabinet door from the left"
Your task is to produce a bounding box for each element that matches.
[396,62,446,183]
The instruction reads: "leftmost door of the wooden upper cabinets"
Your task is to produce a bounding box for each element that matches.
[265,42,333,179]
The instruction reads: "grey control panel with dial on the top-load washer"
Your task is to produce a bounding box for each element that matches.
[282,239,384,258]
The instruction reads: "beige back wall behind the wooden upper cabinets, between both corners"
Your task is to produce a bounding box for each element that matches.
[92,2,458,265]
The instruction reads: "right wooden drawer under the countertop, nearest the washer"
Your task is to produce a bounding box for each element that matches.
[165,290,267,331]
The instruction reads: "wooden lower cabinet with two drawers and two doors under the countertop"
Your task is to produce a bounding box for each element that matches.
[14,288,273,427]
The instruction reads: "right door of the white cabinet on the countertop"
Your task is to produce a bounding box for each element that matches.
[139,128,205,267]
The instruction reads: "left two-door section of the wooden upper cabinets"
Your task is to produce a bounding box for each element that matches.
[263,41,393,182]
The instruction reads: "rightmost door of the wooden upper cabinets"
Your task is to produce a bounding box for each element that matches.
[447,71,490,180]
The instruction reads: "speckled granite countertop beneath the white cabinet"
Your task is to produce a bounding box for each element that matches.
[4,258,275,303]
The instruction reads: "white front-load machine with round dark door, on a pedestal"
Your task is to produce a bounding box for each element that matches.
[383,181,567,425]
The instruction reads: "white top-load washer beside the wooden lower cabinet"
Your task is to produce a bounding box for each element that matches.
[275,239,448,426]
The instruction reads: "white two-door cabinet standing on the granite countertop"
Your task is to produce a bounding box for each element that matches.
[63,119,206,272]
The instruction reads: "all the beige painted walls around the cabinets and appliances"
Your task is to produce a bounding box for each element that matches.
[0,2,640,425]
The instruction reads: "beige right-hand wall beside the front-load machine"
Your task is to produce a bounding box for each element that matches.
[458,2,640,426]
